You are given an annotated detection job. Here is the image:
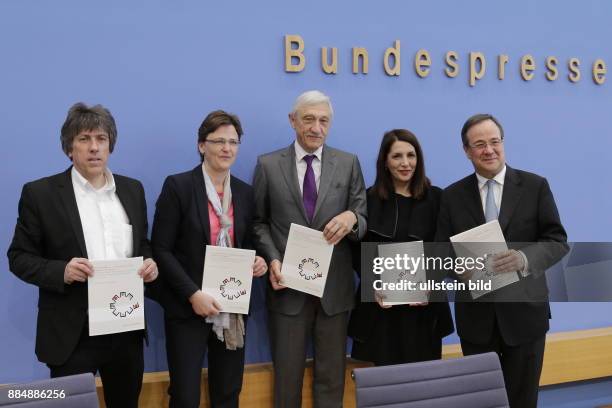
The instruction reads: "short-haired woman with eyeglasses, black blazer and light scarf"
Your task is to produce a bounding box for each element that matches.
[152,110,267,407]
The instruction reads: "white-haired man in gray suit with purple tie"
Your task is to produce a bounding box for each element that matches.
[253,91,366,407]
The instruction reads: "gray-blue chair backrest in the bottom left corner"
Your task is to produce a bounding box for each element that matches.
[0,373,98,408]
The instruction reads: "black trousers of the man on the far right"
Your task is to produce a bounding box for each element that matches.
[461,325,546,408]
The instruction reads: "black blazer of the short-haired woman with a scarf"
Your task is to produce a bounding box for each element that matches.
[151,165,254,318]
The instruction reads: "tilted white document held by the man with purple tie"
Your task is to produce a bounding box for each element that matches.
[281,224,334,297]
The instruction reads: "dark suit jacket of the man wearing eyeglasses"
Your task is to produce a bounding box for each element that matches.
[436,166,568,345]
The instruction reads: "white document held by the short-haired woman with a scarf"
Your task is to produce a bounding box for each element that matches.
[202,245,255,314]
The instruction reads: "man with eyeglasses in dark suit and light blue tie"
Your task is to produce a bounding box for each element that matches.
[436,114,567,408]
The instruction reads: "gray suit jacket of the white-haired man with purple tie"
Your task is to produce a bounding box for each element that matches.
[253,143,367,315]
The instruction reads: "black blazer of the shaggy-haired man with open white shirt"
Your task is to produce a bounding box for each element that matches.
[7,167,152,365]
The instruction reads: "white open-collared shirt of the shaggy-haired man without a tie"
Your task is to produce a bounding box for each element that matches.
[71,167,133,260]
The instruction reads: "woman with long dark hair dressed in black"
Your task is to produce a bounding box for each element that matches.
[349,129,454,365]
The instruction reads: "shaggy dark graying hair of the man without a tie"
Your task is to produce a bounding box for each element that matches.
[60,102,117,157]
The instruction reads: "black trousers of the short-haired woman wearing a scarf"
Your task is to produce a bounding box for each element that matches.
[164,317,246,408]
